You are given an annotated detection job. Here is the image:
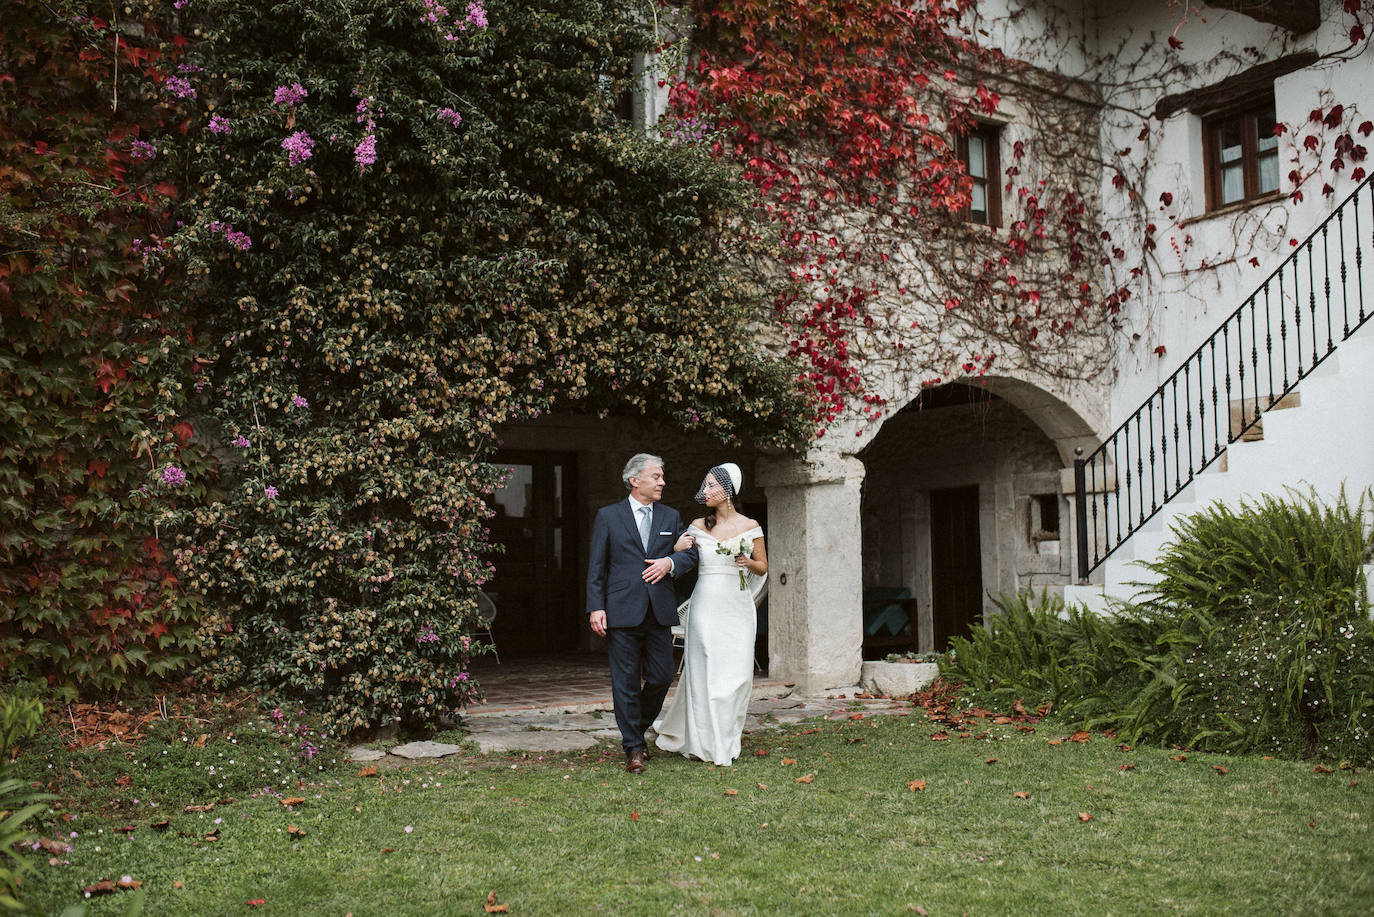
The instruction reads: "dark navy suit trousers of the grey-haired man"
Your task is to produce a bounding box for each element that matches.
[606,612,673,752]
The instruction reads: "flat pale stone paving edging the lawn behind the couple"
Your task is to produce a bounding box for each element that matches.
[349,681,912,763]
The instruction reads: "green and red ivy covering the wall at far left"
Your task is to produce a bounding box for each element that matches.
[0,0,214,694]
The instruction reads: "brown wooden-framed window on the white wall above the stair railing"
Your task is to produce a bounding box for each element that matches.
[1202,92,1279,210]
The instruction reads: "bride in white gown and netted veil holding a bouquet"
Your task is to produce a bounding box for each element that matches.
[654,462,768,764]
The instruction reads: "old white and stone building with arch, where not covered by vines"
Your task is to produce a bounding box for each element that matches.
[480,0,1374,692]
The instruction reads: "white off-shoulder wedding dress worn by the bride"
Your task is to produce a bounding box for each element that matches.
[654,525,764,764]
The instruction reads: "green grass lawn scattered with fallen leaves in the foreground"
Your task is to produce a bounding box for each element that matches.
[19,709,1374,917]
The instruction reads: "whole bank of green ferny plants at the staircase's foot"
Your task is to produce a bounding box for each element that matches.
[947,495,1374,763]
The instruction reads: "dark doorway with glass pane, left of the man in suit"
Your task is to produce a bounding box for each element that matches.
[482,452,581,656]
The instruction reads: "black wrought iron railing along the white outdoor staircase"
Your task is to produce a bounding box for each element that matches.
[1073,176,1374,582]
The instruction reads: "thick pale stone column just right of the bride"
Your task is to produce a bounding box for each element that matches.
[757,456,864,694]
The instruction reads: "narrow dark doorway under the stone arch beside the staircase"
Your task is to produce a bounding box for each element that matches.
[930,487,982,650]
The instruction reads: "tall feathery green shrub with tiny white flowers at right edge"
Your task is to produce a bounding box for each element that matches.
[1125,494,1374,762]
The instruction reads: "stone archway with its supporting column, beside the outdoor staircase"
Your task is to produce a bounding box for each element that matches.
[757,377,1107,693]
